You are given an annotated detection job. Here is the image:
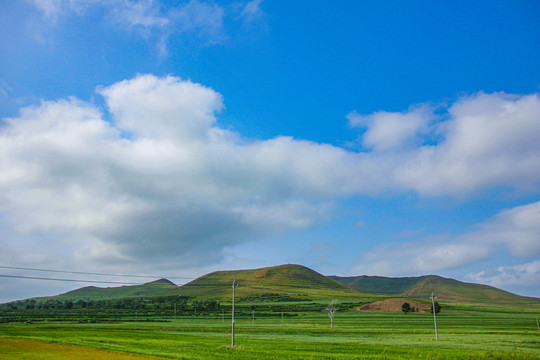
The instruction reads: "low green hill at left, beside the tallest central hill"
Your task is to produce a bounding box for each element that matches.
[51,279,178,300]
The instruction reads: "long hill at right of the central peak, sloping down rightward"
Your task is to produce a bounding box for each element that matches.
[329,275,540,307]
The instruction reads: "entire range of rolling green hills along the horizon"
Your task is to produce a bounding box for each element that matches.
[16,264,540,308]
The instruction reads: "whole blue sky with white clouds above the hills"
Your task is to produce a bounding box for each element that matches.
[0,0,540,302]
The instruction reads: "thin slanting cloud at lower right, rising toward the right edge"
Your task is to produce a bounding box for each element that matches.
[351,202,540,276]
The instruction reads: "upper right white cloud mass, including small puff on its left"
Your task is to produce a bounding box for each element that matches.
[348,93,540,196]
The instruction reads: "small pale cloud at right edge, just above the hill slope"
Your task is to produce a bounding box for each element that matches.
[467,260,540,297]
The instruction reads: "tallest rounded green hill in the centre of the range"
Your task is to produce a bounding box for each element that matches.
[162,264,366,301]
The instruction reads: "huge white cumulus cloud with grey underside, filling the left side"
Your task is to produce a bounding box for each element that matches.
[0,75,362,265]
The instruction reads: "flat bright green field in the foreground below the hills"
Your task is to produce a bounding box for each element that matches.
[0,306,540,359]
